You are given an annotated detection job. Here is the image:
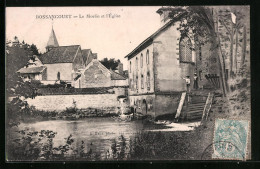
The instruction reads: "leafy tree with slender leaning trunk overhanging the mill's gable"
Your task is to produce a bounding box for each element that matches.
[170,6,227,96]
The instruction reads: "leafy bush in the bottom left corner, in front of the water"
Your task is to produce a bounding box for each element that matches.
[7,129,74,161]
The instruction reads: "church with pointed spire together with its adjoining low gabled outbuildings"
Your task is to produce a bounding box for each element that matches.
[17,27,128,88]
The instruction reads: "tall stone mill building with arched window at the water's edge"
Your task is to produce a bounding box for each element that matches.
[125,7,216,117]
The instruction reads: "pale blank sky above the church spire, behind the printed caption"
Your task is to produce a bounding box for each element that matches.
[6,6,160,70]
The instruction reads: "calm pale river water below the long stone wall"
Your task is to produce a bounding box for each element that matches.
[9,118,166,159]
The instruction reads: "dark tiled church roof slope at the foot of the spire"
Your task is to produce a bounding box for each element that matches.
[39,45,80,64]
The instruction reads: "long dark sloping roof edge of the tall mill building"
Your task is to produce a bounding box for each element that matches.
[125,13,185,59]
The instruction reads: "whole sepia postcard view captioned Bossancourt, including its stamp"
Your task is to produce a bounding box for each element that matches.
[5,5,252,162]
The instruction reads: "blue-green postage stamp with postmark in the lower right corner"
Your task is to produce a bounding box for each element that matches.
[212,119,249,160]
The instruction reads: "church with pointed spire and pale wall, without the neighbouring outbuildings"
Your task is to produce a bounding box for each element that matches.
[36,28,97,86]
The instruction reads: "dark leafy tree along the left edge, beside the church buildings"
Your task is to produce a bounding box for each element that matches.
[6,42,37,126]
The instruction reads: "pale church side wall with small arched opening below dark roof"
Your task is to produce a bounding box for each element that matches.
[44,63,72,80]
